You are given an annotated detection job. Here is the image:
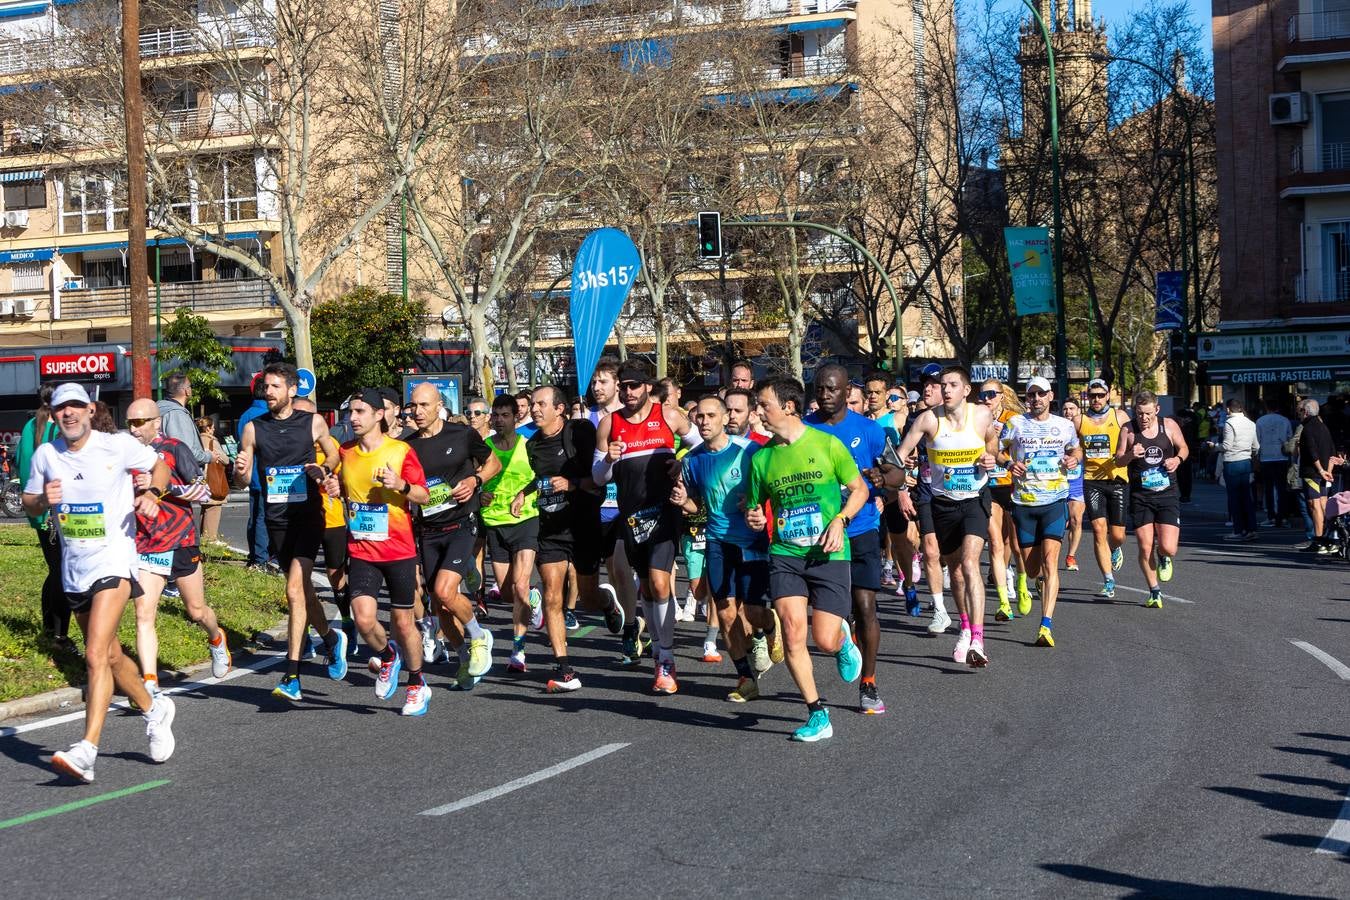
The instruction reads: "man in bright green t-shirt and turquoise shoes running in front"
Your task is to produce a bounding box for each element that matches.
[745,378,868,742]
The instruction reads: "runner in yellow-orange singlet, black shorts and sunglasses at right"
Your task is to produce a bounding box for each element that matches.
[1079,378,1130,599]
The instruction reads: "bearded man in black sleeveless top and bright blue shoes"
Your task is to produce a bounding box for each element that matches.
[235,363,347,700]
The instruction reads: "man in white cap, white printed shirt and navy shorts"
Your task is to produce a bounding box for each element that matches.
[999,376,1079,646]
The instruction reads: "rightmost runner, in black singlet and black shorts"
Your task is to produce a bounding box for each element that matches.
[1116,390,1191,610]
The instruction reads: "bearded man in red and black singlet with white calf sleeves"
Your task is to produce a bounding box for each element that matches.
[602,362,702,694]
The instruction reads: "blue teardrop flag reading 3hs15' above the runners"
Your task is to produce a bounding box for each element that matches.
[571,228,641,393]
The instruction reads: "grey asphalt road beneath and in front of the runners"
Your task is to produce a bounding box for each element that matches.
[0,488,1350,897]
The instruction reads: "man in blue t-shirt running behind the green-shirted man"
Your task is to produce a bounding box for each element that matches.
[803,363,886,715]
